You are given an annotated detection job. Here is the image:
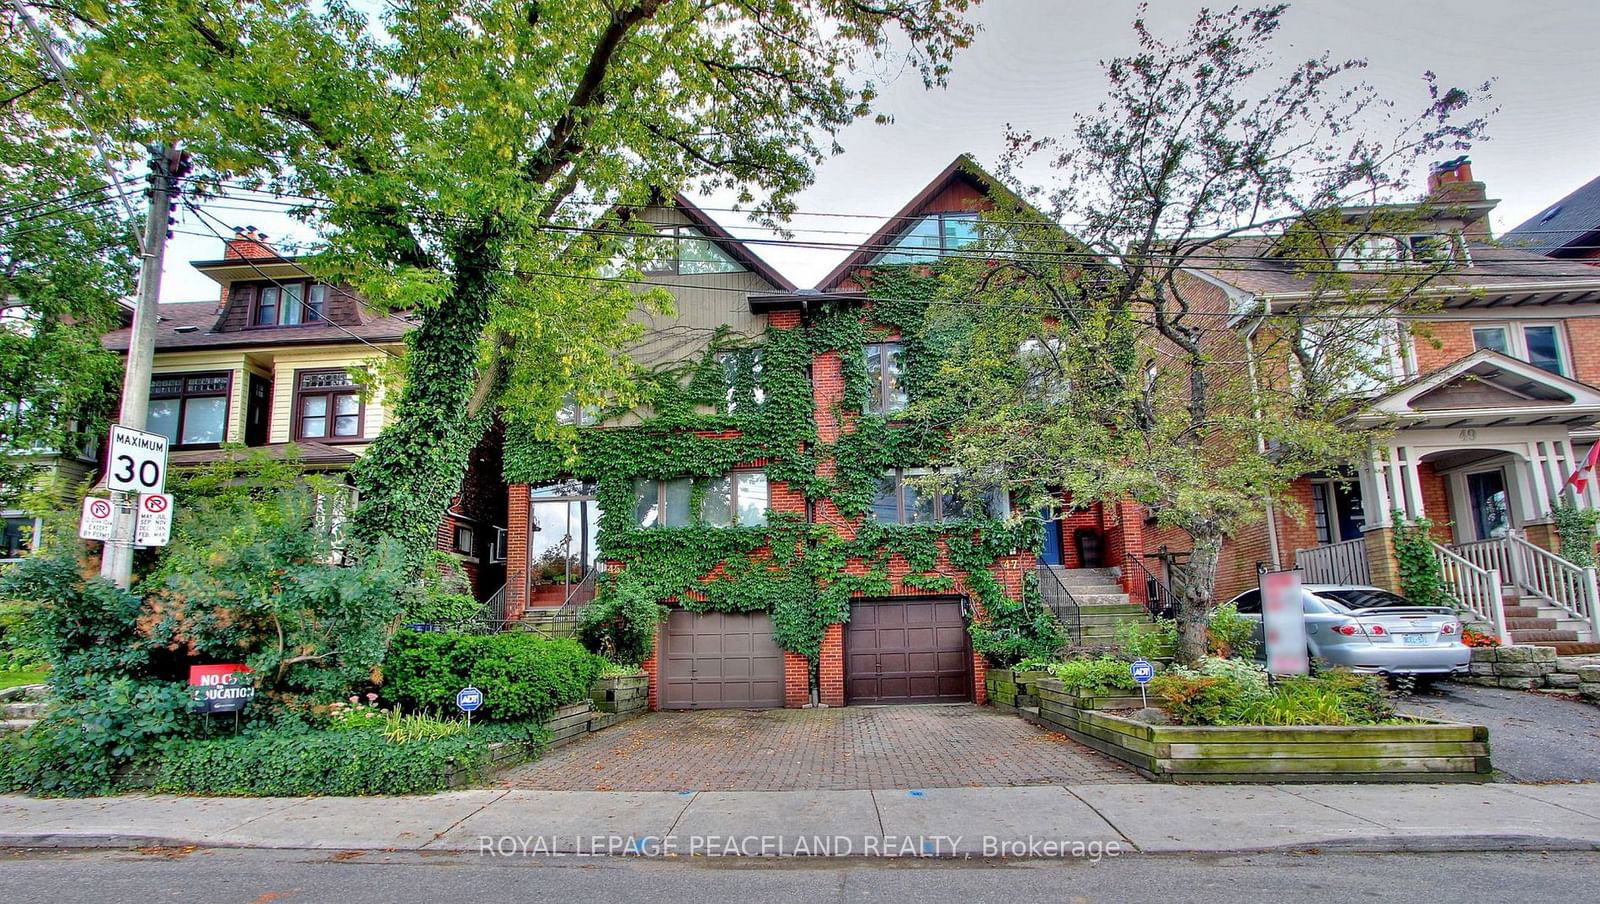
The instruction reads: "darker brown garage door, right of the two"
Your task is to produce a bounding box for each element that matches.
[845,600,973,702]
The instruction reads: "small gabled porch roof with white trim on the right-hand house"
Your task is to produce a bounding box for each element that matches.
[1355,349,1600,427]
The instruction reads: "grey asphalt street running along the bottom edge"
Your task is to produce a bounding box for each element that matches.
[0,850,1600,904]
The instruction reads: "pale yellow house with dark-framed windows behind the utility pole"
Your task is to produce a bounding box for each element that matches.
[102,232,504,598]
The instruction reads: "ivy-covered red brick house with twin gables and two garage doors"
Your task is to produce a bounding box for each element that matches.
[506,164,1107,709]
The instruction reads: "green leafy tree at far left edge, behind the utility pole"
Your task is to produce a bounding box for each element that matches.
[0,6,139,509]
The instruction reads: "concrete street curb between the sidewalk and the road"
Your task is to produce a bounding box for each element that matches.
[0,832,1600,861]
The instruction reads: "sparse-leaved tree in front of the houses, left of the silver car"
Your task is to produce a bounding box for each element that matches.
[923,6,1488,659]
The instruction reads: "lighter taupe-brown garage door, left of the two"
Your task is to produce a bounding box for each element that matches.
[656,610,784,709]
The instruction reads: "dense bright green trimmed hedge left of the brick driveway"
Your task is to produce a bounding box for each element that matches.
[379,630,606,722]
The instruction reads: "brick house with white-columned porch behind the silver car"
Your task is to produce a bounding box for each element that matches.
[1147,158,1600,640]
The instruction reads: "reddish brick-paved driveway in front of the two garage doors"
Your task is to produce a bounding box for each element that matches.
[501,706,1142,790]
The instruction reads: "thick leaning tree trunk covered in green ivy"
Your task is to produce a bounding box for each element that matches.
[350,254,494,568]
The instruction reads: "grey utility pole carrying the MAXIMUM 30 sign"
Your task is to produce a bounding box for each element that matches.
[101,144,187,589]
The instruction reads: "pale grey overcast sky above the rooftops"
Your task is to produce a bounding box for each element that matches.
[162,0,1600,301]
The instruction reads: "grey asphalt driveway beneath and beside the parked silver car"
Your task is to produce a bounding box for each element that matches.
[1400,682,1600,781]
